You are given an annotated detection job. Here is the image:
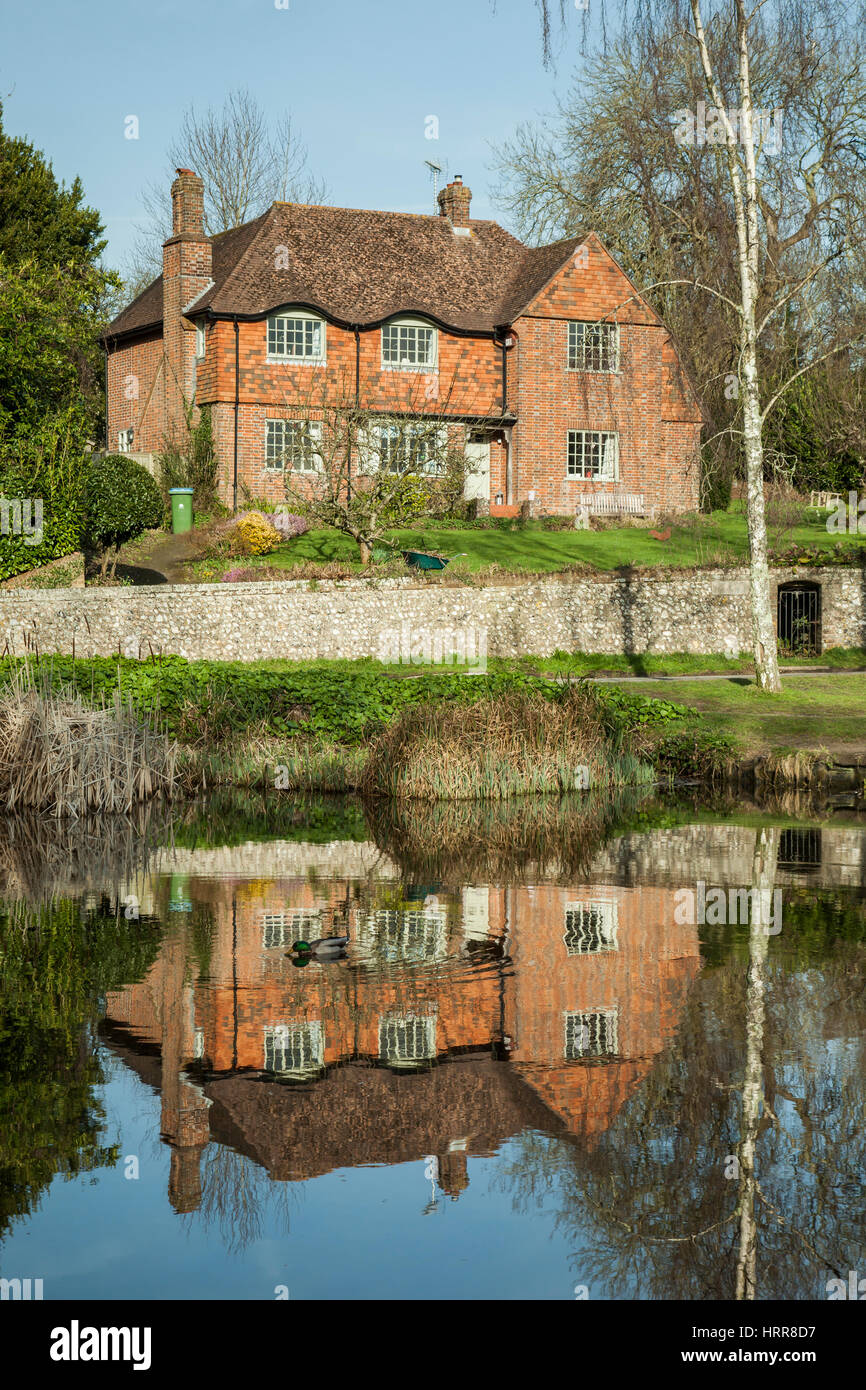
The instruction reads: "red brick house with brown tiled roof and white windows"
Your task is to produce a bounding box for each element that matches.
[103,170,702,513]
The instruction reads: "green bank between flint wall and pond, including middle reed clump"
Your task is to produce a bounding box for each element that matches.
[0,652,866,799]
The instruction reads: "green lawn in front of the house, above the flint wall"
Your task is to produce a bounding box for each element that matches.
[244,505,863,574]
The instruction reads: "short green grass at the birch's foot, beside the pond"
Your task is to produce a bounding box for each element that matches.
[606,674,866,753]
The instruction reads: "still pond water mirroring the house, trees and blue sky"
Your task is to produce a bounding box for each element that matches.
[0,798,866,1300]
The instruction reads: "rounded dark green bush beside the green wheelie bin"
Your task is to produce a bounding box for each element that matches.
[85,453,163,577]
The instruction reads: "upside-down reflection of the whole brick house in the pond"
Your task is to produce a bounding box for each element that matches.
[101,876,699,1211]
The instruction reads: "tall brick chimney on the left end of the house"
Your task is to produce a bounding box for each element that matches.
[163,170,213,432]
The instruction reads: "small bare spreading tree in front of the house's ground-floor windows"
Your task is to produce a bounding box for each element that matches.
[278,374,496,564]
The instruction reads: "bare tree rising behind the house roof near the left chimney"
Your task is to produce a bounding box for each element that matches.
[126,88,328,291]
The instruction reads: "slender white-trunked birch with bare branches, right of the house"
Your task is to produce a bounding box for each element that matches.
[522,0,866,691]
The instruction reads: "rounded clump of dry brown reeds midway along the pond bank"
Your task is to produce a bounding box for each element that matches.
[361,687,652,801]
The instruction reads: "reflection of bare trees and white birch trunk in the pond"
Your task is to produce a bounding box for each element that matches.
[497,831,866,1300]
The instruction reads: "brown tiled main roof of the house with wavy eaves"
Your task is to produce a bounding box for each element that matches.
[108,203,581,336]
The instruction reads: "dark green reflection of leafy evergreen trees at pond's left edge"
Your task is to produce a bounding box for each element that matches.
[0,898,157,1233]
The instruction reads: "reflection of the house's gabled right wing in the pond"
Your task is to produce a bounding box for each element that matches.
[499,884,699,1137]
